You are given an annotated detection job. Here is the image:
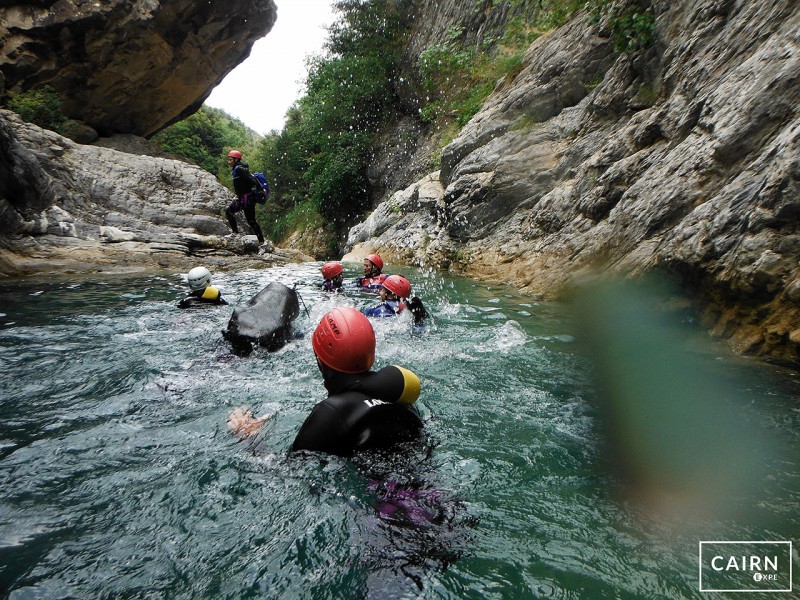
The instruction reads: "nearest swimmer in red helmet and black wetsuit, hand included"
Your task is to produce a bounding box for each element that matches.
[228,307,422,456]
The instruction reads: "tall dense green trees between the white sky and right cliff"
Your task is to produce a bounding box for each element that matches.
[250,0,408,250]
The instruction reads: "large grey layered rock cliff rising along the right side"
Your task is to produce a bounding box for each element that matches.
[348,0,800,361]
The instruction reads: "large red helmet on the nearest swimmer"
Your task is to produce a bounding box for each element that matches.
[311,307,375,373]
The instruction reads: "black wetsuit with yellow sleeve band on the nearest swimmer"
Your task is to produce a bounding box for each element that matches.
[292,365,422,456]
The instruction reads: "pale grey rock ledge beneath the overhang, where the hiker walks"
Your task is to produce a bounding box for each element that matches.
[0,110,309,276]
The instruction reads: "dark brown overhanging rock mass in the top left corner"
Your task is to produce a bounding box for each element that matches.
[0,0,277,137]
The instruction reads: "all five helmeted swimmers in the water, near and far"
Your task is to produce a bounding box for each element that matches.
[173,254,424,456]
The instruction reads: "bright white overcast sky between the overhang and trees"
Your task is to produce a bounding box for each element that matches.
[206,0,333,134]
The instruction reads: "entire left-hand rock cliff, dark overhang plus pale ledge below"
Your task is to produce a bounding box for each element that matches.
[0,0,308,276]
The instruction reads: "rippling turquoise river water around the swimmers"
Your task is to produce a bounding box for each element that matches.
[0,263,800,599]
